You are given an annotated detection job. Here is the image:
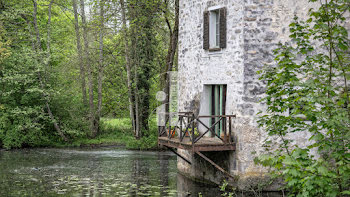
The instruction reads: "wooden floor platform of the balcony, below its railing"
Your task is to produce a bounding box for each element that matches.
[158,137,236,152]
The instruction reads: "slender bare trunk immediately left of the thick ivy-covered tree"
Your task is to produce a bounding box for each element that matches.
[120,0,136,135]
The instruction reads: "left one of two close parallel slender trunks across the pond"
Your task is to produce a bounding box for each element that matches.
[72,0,88,106]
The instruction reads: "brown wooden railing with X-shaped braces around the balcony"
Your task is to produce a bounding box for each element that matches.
[158,112,236,145]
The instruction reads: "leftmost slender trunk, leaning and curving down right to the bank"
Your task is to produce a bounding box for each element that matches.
[33,0,68,141]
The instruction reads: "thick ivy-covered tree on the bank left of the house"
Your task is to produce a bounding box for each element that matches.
[123,0,161,138]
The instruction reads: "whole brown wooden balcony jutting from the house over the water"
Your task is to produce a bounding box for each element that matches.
[158,112,236,152]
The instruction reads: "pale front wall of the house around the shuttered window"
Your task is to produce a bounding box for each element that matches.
[179,0,243,113]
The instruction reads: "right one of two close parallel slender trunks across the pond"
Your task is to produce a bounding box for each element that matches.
[80,0,96,137]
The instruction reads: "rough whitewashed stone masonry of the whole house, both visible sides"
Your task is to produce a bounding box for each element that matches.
[178,0,350,188]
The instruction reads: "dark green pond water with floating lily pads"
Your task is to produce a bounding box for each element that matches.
[0,148,220,197]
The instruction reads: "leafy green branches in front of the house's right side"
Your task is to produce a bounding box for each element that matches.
[256,0,350,196]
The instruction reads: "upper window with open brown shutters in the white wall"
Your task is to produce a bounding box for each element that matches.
[203,8,226,51]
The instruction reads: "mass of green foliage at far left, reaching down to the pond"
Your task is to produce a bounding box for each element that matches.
[0,0,86,149]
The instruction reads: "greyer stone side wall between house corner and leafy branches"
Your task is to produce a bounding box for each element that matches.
[237,0,311,178]
